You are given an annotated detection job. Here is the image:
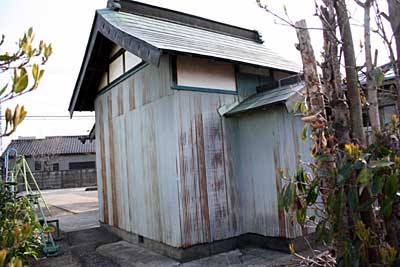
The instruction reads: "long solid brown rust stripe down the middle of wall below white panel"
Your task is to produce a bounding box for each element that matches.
[195,113,211,241]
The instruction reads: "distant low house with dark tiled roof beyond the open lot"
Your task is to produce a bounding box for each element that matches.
[1,136,96,189]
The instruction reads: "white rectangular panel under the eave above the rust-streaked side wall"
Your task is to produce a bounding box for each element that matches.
[176,56,236,91]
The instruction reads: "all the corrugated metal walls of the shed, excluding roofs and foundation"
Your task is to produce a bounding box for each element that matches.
[95,54,308,247]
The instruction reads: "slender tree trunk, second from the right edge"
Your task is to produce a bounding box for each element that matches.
[363,0,381,133]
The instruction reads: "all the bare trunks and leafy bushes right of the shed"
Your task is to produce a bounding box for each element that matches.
[258,0,400,267]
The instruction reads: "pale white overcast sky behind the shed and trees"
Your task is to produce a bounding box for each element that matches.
[0,0,394,152]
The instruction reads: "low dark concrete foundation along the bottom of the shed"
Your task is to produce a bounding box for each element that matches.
[100,222,314,262]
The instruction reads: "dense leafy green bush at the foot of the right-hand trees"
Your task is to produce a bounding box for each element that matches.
[282,116,400,266]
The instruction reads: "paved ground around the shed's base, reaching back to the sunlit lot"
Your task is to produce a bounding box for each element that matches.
[34,188,298,267]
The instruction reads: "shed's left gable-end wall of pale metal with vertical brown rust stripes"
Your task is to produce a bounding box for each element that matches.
[96,57,181,247]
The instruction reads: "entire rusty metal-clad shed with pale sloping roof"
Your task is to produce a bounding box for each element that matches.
[69,0,309,260]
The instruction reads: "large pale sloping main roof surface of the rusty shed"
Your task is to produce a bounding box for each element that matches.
[97,9,301,72]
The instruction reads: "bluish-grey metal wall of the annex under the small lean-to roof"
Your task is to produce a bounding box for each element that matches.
[234,106,310,238]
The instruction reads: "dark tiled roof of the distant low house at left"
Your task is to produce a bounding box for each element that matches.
[2,136,96,157]
